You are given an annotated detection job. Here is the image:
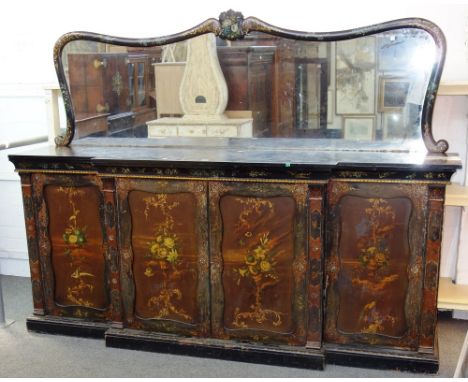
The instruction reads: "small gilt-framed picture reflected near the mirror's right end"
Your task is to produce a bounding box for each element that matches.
[379,77,411,113]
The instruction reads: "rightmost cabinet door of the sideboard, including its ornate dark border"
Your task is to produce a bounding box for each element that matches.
[325,182,428,350]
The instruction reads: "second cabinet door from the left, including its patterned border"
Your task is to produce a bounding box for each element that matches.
[117,179,209,336]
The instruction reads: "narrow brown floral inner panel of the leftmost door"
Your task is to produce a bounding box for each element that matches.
[44,185,107,309]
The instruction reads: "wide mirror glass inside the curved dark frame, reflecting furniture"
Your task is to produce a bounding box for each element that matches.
[62,28,436,147]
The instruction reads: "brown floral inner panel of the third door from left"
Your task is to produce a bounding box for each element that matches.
[220,195,295,332]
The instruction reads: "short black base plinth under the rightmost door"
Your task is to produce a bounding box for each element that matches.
[324,344,439,374]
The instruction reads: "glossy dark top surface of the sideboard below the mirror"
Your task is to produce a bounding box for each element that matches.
[10,138,461,171]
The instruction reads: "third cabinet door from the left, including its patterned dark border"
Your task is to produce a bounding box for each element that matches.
[209,182,307,345]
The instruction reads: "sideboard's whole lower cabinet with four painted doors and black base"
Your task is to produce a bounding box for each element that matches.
[9,149,456,371]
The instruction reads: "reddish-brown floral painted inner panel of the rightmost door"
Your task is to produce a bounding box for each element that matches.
[337,196,411,337]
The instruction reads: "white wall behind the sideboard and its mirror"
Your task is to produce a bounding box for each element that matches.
[0,0,468,283]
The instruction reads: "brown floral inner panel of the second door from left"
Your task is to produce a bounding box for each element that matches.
[129,191,198,323]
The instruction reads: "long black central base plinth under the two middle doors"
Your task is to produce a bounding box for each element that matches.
[105,328,324,370]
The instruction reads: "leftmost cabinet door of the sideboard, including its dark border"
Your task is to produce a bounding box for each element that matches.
[33,174,116,320]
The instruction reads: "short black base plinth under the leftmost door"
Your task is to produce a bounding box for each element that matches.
[26,316,109,339]
